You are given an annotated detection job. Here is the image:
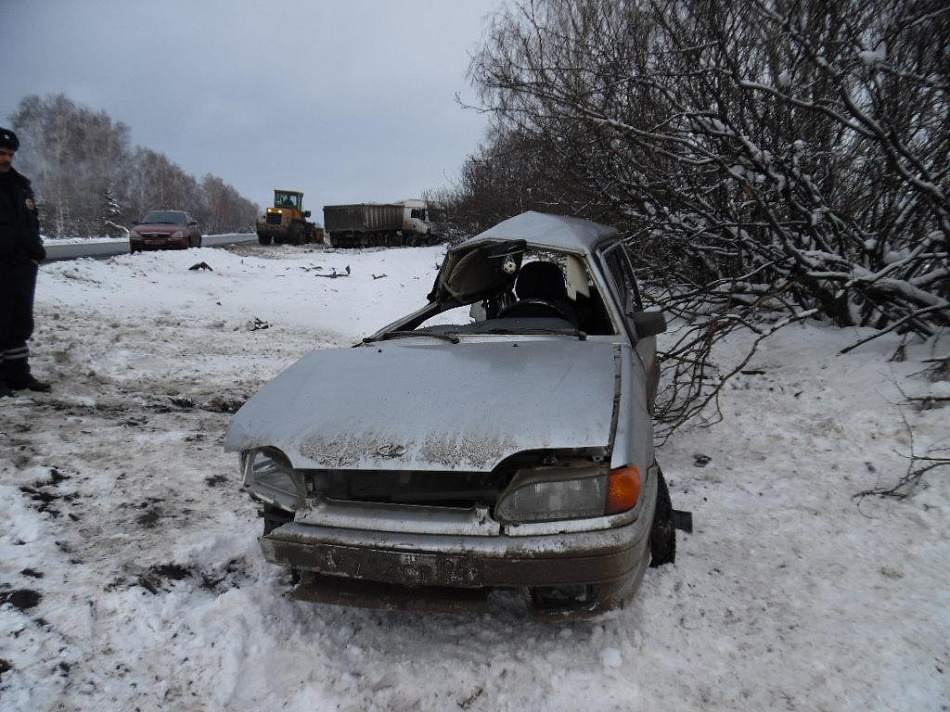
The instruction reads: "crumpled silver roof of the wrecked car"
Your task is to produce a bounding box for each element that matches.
[456,210,618,255]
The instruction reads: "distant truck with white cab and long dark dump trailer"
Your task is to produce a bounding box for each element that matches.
[323,200,440,247]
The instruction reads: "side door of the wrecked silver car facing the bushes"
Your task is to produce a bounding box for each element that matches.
[600,241,665,413]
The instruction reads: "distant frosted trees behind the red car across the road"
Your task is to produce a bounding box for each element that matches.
[11,94,258,237]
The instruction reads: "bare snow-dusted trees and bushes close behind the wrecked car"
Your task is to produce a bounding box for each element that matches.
[438,0,950,434]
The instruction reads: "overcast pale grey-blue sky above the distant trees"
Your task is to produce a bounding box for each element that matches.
[0,0,502,210]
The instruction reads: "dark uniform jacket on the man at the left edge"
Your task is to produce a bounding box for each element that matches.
[0,168,46,264]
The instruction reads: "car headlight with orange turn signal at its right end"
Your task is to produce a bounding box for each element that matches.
[495,463,642,524]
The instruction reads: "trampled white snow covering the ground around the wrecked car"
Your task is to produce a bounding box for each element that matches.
[0,245,950,712]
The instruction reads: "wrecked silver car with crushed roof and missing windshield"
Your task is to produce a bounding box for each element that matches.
[225,212,675,615]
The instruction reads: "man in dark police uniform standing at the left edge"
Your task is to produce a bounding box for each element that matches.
[0,128,50,396]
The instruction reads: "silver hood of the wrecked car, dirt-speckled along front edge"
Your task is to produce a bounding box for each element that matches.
[225,337,619,472]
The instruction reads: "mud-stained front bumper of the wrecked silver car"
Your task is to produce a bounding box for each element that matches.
[260,522,649,615]
